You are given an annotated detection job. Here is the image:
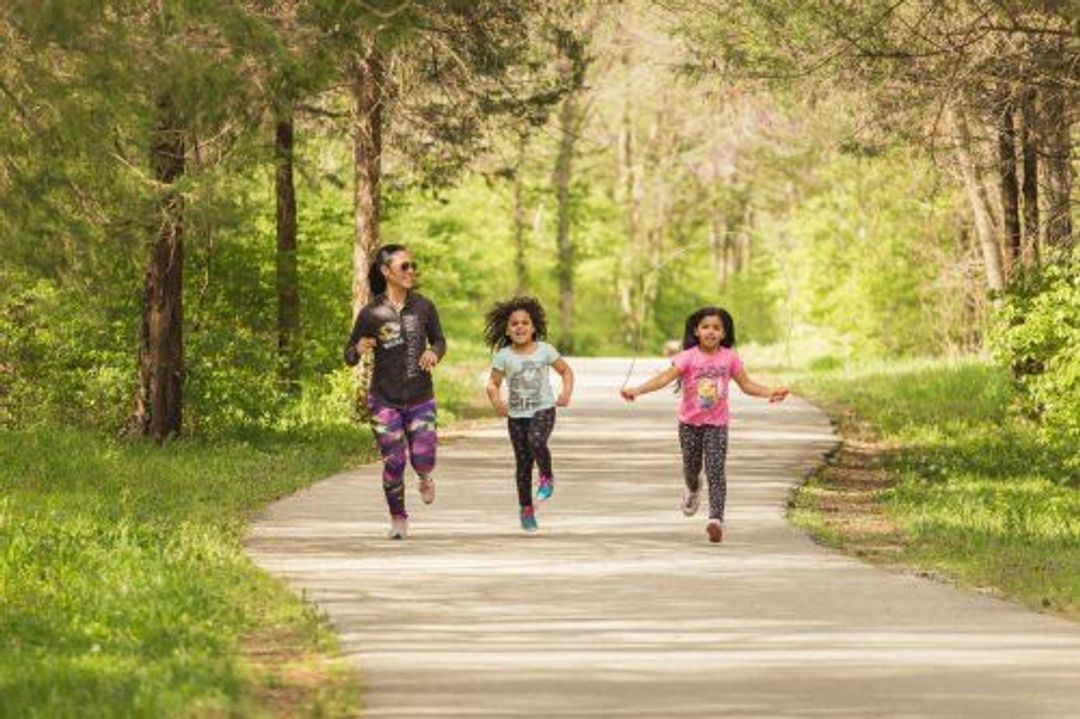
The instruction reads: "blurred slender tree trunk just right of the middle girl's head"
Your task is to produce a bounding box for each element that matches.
[554,90,579,354]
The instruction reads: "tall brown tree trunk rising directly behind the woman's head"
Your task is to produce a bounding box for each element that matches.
[352,44,384,317]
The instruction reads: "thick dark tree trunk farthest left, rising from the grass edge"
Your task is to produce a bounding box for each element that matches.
[130,95,185,444]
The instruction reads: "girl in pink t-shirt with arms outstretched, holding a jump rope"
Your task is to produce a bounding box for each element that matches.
[621,307,788,542]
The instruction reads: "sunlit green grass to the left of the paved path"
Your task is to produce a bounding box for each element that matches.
[0,425,369,717]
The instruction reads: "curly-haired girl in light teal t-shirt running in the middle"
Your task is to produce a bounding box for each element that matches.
[484,297,573,532]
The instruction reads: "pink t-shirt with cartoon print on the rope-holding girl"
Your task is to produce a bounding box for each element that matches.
[672,347,742,425]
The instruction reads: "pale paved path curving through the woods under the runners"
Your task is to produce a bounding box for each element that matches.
[248,360,1080,719]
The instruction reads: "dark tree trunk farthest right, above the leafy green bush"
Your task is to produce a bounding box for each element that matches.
[1041,87,1074,256]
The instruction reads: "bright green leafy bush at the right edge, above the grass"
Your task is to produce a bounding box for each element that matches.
[991,259,1080,449]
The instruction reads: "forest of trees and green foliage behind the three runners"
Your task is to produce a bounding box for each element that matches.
[0,1,1078,439]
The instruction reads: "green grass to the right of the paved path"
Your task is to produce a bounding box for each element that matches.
[796,360,1080,616]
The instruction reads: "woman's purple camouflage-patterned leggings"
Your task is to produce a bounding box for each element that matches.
[367,395,438,517]
